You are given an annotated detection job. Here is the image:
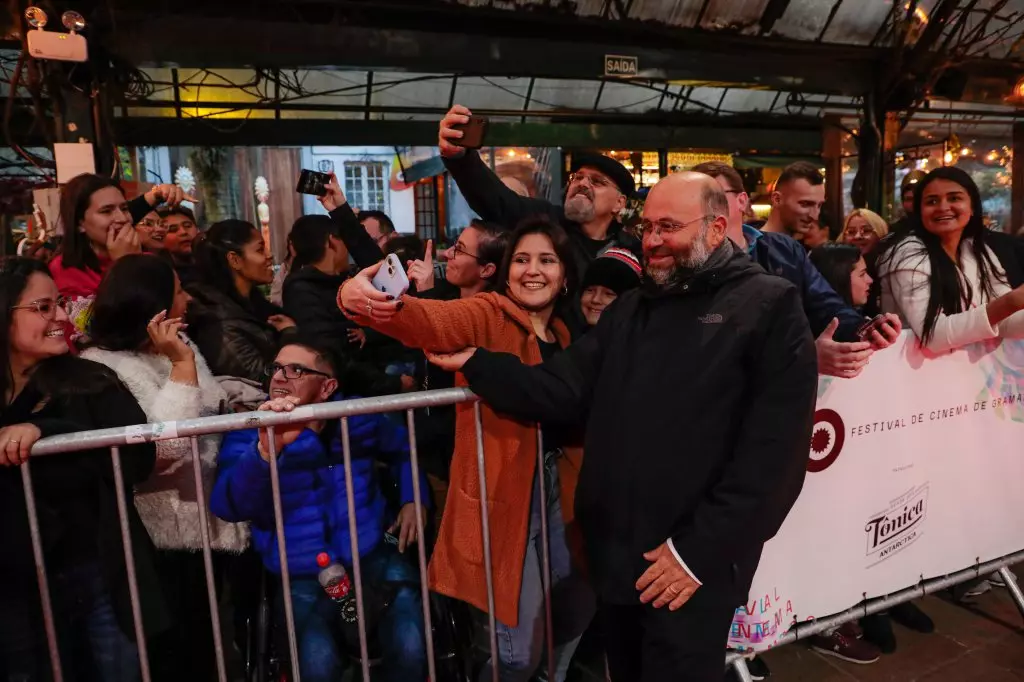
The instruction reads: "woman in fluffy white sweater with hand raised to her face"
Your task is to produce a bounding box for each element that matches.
[82,255,249,679]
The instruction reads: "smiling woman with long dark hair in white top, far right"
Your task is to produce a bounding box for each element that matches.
[879,167,1024,352]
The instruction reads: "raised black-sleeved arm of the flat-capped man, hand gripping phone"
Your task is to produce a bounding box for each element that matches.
[437,104,562,229]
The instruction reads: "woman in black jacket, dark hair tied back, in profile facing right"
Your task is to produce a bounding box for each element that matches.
[186,220,295,384]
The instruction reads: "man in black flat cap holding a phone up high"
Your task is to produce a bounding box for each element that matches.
[437,104,641,333]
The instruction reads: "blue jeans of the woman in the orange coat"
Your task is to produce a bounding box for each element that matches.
[479,453,597,682]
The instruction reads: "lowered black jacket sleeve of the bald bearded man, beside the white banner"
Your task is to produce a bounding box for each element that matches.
[672,288,818,577]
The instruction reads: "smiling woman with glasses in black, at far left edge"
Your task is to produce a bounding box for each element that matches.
[0,258,167,681]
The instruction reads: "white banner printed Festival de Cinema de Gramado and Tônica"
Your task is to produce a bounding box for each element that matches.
[729,333,1024,649]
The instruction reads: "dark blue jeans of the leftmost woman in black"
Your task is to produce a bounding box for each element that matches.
[52,563,141,682]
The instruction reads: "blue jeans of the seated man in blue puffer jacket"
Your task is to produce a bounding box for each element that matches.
[276,545,427,682]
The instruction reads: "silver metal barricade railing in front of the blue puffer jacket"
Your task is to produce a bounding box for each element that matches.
[22,388,569,682]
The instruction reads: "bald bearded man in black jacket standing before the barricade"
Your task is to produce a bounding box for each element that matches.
[434,173,817,682]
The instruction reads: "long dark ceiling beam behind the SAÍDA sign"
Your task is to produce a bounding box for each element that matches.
[104,12,885,95]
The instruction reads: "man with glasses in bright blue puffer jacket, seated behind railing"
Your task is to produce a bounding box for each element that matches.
[210,342,429,682]
